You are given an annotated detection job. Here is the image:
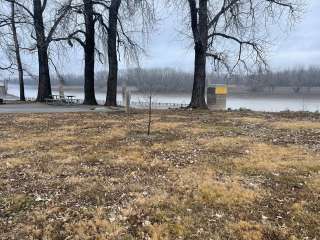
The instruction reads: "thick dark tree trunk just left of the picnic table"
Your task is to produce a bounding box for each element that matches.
[33,0,52,102]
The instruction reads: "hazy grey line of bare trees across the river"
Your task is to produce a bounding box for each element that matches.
[10,67,320,93]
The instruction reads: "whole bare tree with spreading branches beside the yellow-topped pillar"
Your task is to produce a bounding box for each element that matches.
[175,0,298,108]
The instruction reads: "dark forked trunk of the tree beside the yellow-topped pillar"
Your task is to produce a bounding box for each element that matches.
[188,0,208,108]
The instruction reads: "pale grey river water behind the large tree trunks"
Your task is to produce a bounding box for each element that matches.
[8,84,320,112]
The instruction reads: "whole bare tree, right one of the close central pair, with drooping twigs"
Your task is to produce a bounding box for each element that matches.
[105,0,155,106]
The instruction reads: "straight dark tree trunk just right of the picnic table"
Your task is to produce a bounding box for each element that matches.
[83,0,97,105]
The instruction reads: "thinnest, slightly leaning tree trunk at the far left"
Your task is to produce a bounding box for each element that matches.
[11,2,26,101]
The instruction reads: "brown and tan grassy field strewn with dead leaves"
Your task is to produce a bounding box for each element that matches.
[0,111,320,240]
